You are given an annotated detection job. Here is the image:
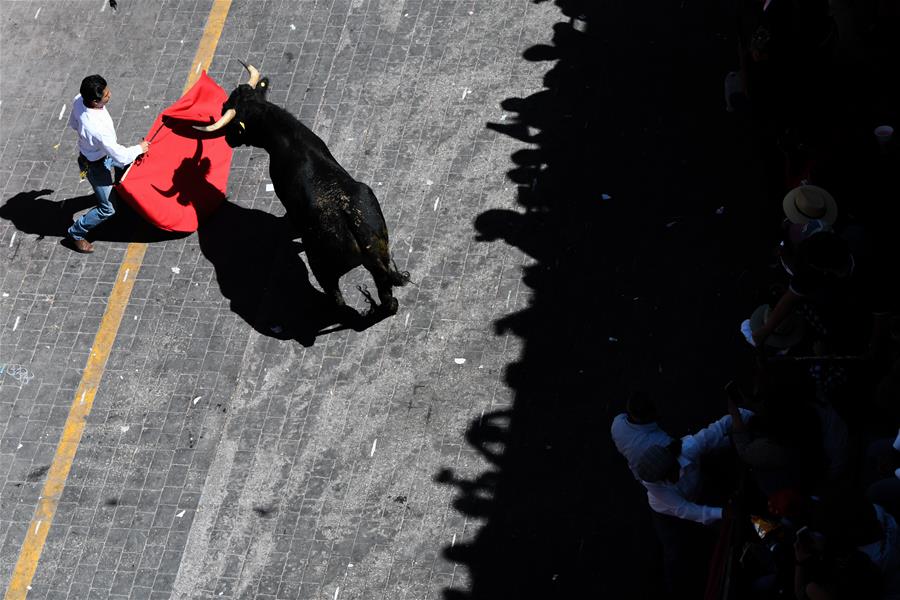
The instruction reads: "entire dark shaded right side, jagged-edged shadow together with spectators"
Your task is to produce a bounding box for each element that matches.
[436,0,900,600]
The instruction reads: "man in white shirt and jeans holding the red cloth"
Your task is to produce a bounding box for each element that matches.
[66,75,150,254]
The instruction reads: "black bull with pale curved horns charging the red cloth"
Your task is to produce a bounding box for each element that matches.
[197,67,409,314]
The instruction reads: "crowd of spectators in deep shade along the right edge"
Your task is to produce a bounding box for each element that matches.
[611,0,900,600]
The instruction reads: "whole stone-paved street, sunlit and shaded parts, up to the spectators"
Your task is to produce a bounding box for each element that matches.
[0,0,880,600]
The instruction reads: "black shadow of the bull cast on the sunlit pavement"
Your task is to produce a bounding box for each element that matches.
[197,201,377,346]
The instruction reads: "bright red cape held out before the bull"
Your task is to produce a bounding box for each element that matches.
[116,71,231,233]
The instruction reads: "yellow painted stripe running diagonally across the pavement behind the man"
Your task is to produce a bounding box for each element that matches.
[4,0,231,600]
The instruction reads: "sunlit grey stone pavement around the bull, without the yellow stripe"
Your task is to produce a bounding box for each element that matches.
[0,0,563,600]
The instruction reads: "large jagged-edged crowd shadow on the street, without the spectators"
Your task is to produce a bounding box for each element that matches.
[435,0,758,600]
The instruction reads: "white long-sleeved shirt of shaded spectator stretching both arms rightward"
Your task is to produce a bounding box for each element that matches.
[642,408,753,525]
